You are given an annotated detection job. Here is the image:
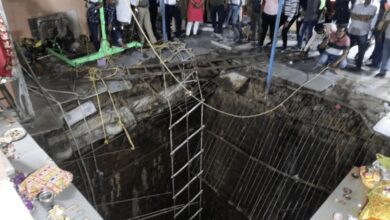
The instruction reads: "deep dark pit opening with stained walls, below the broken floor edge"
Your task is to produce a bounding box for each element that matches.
[38,78,385,220]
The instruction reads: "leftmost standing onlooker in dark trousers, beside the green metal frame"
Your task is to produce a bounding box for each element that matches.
[87,0,103,51]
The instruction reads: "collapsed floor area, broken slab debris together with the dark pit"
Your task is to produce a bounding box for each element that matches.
[20,41,388,220]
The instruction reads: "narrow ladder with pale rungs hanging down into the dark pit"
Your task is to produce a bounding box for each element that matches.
[169,71,205,220]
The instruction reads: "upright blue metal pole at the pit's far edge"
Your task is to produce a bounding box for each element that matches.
[265,0,284,97]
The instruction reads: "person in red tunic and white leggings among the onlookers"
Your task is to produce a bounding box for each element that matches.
[186,0,203,37]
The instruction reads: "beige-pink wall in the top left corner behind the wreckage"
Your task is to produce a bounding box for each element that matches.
[3,0,88,39]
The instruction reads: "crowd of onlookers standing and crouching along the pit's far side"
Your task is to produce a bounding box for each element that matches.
[87,0,390,77]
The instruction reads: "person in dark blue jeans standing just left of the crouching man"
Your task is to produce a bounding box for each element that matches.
[297,0,320,49]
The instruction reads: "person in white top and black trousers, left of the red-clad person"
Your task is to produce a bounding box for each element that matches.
[164,0,181,41]
